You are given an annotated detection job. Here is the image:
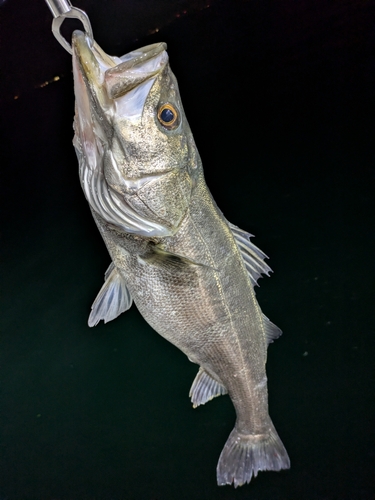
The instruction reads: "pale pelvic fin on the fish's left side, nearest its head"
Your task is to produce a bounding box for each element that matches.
[88,262,133,326]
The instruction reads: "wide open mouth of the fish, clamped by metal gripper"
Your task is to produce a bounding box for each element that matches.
[72,30,168,100]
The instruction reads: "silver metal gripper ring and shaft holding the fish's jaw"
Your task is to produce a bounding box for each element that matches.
[46,0,94,54]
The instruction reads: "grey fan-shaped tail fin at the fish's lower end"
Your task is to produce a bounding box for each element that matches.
[216,423,290,488]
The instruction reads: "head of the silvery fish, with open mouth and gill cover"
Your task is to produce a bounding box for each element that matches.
[72,31,201,236]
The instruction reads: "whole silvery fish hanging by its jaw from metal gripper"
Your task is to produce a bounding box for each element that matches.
[72,31,290,487]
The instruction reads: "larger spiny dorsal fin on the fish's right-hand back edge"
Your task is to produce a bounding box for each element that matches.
[227,221,272,286]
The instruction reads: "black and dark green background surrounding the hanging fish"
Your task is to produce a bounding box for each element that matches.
[0,0,375,500]
